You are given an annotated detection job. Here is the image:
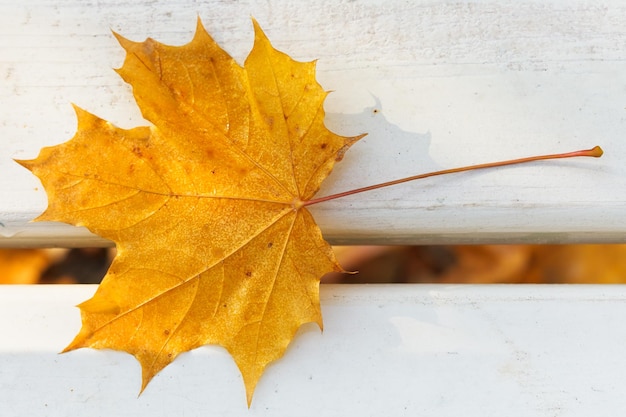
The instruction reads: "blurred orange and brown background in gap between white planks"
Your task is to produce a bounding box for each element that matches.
[0,245,626,284]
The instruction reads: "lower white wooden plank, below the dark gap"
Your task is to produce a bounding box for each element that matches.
[0,285,626,417]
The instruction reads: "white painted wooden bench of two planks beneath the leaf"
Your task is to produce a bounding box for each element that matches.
[0,0,626,417]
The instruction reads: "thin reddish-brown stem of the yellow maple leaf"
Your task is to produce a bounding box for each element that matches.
[301,146,603,206]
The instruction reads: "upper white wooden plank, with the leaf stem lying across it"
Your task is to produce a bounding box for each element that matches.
[0,0,626,246]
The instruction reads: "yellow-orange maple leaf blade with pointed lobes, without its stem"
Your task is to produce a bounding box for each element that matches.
[18,20,361,404]
